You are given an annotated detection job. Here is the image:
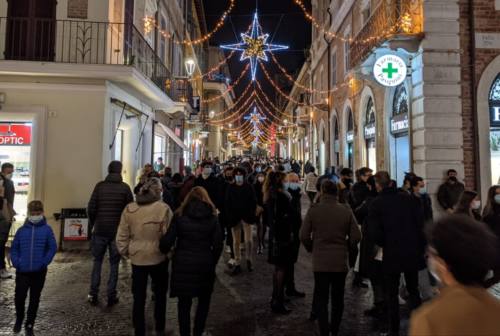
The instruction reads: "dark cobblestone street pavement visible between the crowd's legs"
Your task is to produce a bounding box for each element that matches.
[0,198,500,336]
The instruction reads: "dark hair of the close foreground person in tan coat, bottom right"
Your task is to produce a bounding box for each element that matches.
[428,215,498,285]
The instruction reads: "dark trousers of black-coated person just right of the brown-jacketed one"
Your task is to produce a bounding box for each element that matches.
[384,271,422,335]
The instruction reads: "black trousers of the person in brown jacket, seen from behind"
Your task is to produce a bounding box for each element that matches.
[314,272,347,336]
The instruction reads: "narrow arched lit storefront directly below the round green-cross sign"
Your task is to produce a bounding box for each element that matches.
[389,84,412,185]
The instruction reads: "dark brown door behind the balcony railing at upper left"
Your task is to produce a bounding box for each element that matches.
[5,0,57,61]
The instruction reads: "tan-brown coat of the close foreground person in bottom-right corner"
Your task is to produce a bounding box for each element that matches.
[409,286,500,336]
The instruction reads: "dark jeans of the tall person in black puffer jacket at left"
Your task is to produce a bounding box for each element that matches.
[89,235,120,299]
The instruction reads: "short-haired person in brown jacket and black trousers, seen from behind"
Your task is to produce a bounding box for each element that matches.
[300,180,361,336]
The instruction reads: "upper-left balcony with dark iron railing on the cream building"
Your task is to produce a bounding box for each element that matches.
[0,17,176,96]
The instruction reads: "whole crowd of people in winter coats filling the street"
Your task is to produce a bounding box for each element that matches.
[0,157,500,336]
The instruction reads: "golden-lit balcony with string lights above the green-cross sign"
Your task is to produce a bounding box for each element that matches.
[350,0,423,68]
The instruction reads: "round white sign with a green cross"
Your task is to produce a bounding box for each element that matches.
[373,55,408,87]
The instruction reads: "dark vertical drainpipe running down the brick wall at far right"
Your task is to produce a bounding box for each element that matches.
[464,0,481,195]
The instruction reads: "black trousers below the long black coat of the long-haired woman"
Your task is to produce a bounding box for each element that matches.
[178,293,212,336]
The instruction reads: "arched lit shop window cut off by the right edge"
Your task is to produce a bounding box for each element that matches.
[489,73,500,184]
